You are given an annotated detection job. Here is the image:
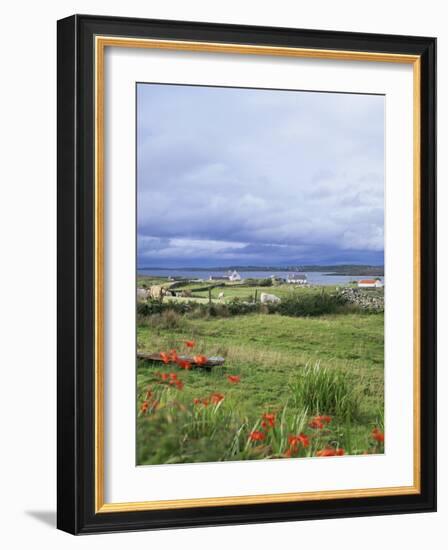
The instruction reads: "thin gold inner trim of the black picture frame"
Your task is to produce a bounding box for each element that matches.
[94,36,421,513]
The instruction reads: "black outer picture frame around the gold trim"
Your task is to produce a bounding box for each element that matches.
[57,15,436,534]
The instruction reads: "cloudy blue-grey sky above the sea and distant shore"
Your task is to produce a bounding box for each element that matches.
[137,83,384,268]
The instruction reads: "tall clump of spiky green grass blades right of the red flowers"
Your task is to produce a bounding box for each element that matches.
[289,363,361,420]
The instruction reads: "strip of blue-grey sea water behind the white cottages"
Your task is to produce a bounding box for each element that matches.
[138,268,384,286]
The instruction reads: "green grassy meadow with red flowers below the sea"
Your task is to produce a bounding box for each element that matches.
[137,279,384,464]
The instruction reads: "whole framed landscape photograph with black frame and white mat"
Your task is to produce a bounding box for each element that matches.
[58,15,436,534]
